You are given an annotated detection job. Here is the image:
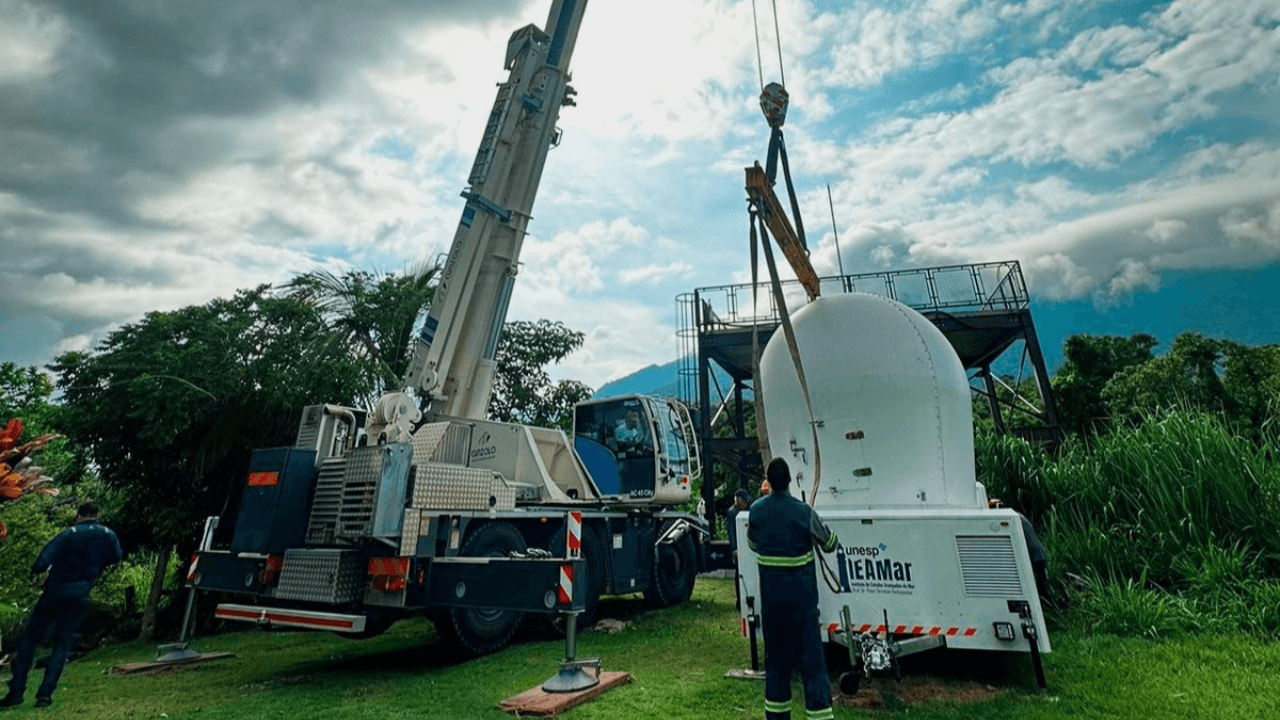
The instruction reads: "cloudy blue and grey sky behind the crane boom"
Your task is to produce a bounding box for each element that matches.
[0,0,1280,386]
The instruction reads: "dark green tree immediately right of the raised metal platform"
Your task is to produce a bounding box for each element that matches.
[1052,333,1160,433]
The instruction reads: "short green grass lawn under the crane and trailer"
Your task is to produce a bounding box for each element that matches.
[9,578,1280,720]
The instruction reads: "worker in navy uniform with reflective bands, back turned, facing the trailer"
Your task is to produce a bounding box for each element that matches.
[746,457,840,720]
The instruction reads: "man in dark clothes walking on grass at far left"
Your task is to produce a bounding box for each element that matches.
[0,502,123,707]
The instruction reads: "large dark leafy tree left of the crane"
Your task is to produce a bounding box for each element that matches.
[51,286,371,634]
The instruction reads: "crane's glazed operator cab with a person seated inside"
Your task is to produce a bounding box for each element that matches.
[573,395,700,505]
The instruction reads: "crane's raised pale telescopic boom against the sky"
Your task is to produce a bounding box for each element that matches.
[404,0,586,419]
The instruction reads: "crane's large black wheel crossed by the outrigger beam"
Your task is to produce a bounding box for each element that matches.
[436,521,526,655]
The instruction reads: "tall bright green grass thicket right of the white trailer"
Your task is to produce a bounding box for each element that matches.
[978,410,1280,638]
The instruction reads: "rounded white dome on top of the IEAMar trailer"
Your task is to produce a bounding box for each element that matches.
[759,292,979,510]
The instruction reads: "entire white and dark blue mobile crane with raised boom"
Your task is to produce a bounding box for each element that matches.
[188,0,705,653]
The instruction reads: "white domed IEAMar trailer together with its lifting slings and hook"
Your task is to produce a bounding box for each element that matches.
[730,83,1050,694]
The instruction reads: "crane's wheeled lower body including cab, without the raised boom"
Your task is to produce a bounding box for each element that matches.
[189,395,704,655]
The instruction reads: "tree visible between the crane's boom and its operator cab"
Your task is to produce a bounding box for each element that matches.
[489,320,591,430]
